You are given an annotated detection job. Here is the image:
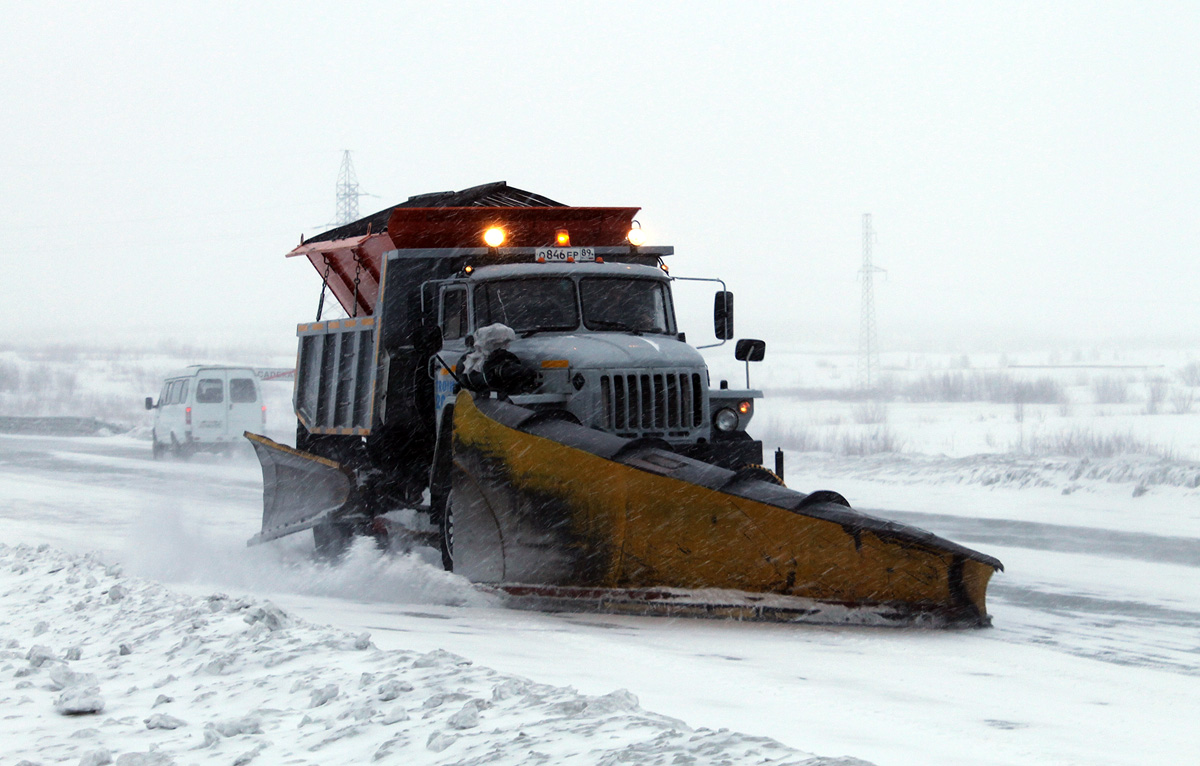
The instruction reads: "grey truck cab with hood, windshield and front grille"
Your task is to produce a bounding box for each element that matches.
[431,259,762,469]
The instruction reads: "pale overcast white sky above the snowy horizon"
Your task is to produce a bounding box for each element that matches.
[0,0,1200,351]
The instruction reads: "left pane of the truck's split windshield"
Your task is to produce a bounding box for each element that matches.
[475,277,580,333]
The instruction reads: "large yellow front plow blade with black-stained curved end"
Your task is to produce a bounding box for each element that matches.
[446,391,1003,626]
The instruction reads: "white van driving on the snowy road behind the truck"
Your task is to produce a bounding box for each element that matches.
[146,365,266,460]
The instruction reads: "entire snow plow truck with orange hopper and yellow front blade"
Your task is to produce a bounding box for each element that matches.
[246,181,1002,626]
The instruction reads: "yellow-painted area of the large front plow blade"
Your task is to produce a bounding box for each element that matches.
[455,391,992,615]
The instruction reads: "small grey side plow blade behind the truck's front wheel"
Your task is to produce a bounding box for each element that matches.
[245,431,354,545]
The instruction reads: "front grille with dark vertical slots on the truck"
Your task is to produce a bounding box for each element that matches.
[600,370,704,436]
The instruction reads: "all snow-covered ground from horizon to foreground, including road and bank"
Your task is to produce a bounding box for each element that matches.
[0,348,1200,766]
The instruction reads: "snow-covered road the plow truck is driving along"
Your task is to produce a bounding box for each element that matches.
[0,436,1200,766]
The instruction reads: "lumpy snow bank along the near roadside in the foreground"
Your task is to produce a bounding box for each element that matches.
[0,545,864,766]
